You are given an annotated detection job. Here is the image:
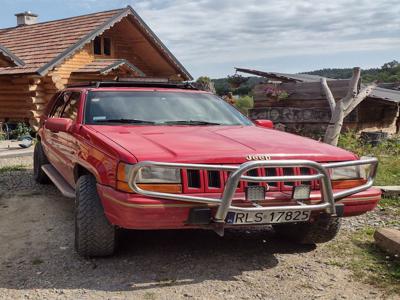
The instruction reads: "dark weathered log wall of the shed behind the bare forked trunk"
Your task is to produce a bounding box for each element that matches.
[249,80,399,136]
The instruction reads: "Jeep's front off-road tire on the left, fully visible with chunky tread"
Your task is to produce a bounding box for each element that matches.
[75,175,116,257]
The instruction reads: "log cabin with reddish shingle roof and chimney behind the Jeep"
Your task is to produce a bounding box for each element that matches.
[0,6,192,128]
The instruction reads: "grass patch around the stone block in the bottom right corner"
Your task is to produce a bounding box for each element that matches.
[327,227,400,294]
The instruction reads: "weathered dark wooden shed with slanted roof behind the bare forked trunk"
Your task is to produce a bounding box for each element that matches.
[237,68,400,136]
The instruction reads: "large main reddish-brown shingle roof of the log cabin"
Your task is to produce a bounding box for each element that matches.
[0,6,192,79]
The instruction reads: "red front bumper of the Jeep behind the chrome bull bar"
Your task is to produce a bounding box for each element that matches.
[97,185,381,230]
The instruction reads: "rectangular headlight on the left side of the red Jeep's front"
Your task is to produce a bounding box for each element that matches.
[137,167,181,183]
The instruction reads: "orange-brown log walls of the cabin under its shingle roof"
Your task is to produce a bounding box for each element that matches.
[0,20,188,129]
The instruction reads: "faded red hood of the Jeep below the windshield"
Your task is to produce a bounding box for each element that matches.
[88,125,357,163]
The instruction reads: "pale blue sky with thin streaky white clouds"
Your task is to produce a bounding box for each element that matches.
[0,0,400,78]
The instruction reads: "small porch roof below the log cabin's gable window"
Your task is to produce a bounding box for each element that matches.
[74,59,145,76]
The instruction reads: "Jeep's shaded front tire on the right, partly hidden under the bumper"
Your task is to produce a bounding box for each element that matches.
[274,215,341,244]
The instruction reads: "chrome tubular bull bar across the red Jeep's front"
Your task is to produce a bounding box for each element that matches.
[128,158,378,223]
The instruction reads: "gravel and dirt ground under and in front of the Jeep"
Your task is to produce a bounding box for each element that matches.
[0,158,400,299]
